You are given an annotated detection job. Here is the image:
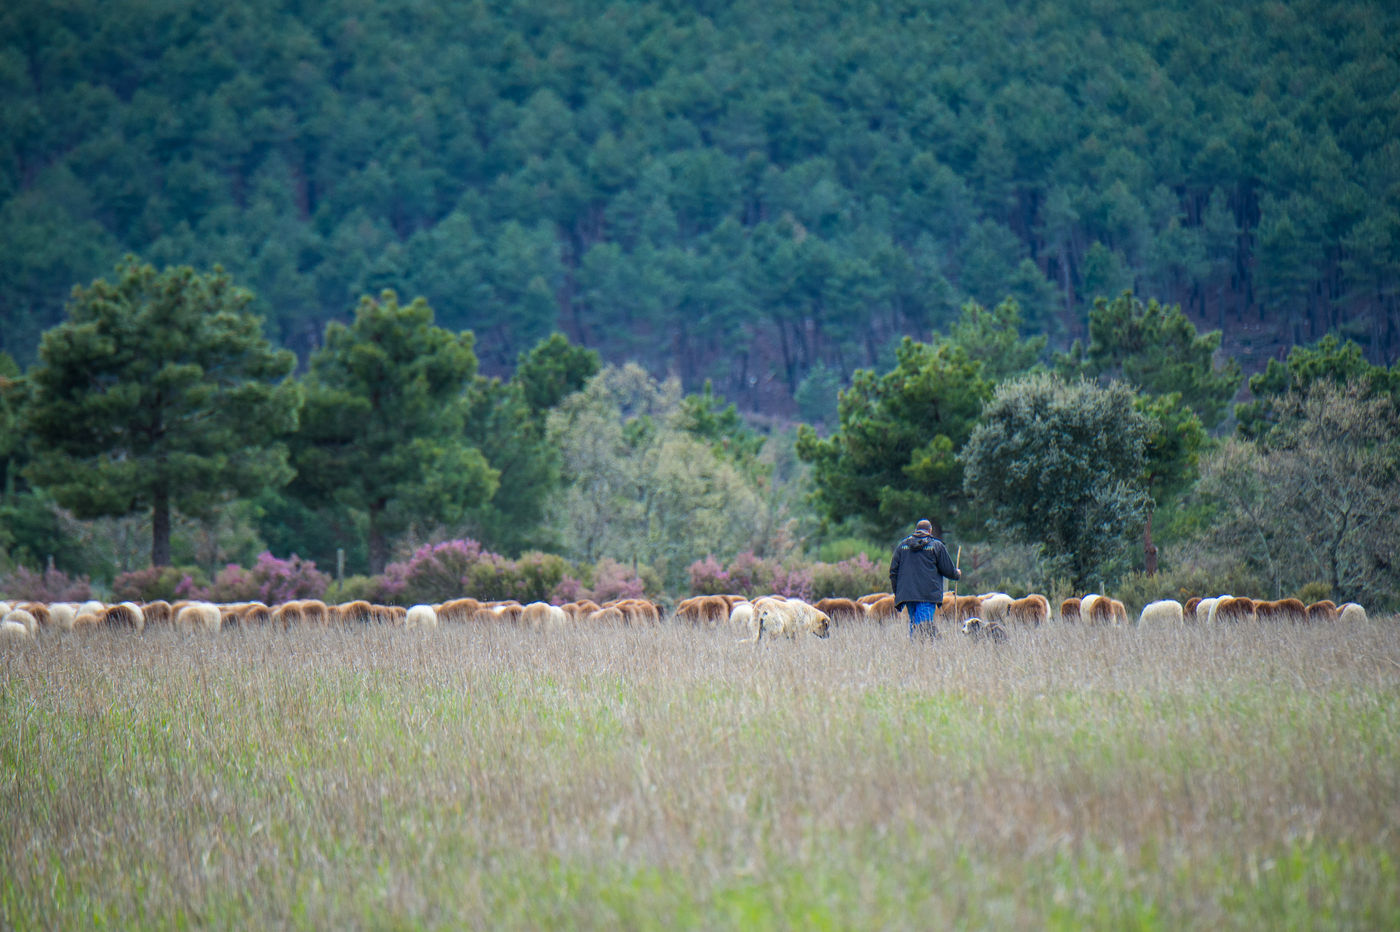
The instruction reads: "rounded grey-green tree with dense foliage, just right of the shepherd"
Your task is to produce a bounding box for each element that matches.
[959,374,1149,592]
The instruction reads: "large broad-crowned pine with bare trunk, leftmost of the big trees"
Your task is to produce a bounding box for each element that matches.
[25,259,300,565]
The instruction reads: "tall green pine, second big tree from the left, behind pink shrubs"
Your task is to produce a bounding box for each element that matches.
[290,291,498,572]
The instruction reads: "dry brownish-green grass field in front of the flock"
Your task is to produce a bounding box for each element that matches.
[0,619,1400,929]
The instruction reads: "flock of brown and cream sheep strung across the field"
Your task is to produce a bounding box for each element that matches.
[0,592,1366,642]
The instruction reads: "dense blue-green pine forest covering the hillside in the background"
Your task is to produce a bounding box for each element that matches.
[0,0,1400,414]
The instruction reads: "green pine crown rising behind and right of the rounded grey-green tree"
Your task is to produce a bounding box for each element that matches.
[1060,291,1243,428]
